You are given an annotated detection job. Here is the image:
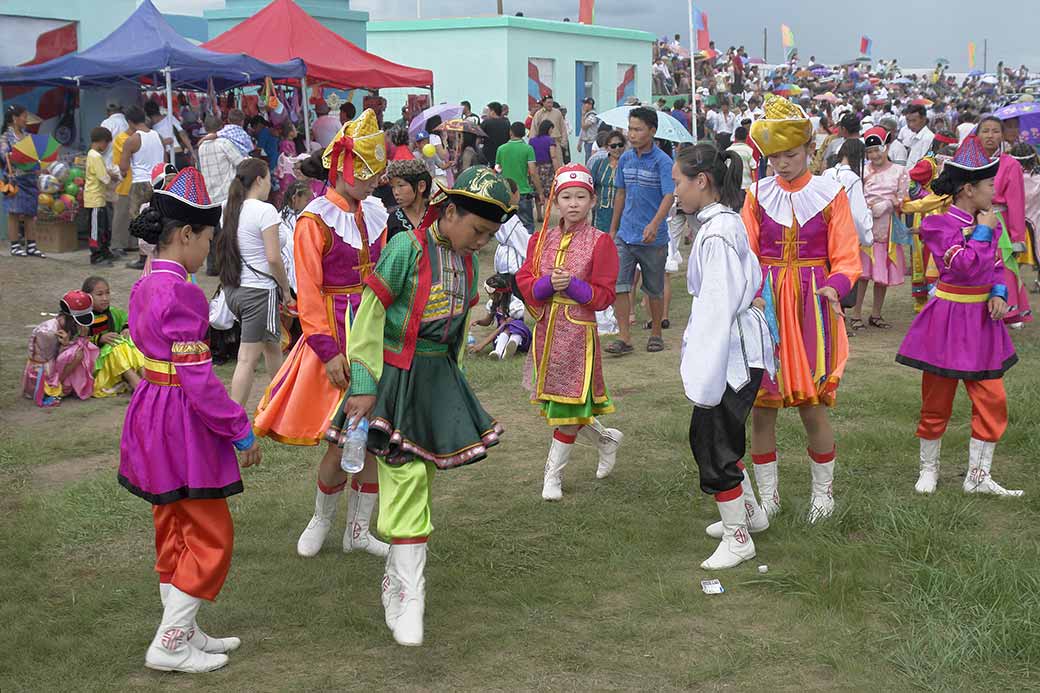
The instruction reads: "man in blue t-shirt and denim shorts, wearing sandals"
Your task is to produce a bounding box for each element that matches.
[606,106,675,355]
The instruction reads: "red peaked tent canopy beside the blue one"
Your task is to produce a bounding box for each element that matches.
[202,0,434,89]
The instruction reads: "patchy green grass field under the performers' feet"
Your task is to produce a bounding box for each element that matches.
[0,245,1040,693]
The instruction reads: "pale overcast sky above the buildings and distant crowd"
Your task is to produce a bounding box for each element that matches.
[154,0,1040,72]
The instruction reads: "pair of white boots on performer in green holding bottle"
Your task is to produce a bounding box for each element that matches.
[383,542,426,647]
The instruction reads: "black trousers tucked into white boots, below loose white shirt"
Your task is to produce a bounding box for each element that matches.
[690,368,762,494]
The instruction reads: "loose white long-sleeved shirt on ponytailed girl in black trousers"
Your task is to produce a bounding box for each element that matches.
[679,203,775,407]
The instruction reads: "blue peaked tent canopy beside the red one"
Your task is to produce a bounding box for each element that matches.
[0,0,307,89]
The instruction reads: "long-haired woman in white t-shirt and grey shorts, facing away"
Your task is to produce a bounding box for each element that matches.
[216,158,291,406]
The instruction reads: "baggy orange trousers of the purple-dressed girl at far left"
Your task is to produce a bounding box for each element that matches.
[152,498,235,601]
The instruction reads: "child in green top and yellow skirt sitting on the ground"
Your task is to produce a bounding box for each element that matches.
[83,277,145,397]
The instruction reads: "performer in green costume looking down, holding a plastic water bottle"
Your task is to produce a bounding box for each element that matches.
[332,166,513,646]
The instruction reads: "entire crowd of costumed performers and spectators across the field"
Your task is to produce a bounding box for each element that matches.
[9,41,1040,672]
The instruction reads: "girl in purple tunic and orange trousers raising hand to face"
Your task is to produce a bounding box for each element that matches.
[895,135,1022,496]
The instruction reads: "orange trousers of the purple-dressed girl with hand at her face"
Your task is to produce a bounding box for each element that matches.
[917,373,1008,442]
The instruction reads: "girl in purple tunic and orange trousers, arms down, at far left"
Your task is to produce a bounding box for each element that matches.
[115,168,260,673]
